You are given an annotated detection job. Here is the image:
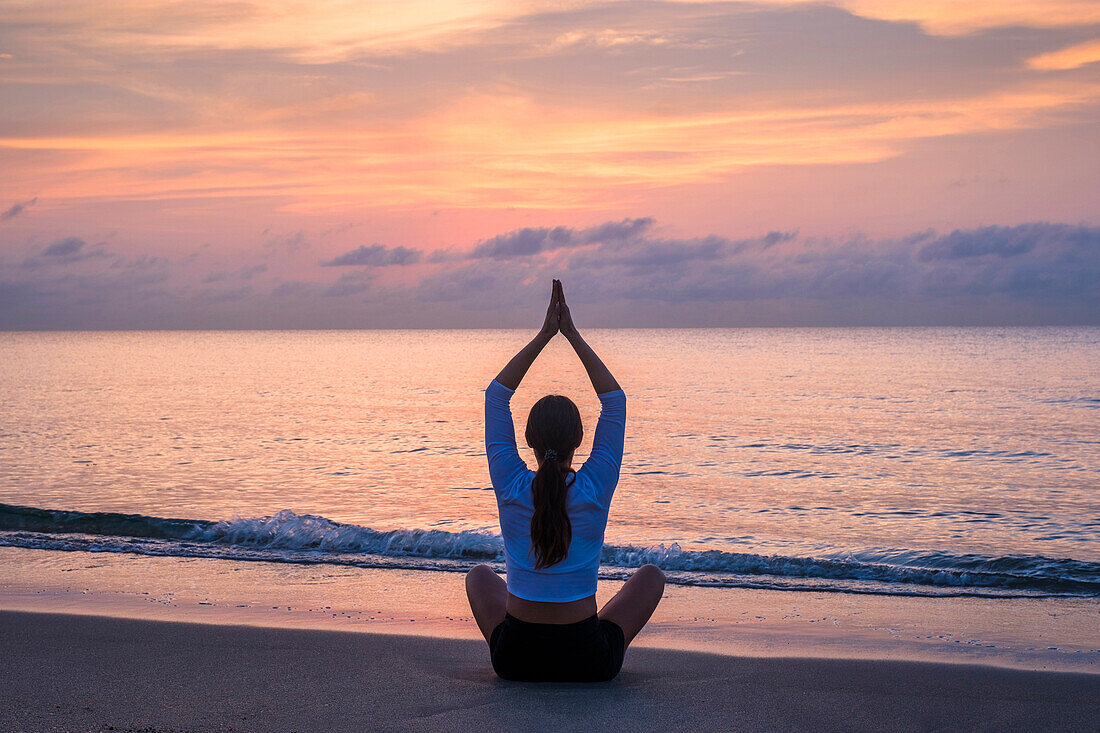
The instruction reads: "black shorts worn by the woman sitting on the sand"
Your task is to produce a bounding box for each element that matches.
[488,613,626,682]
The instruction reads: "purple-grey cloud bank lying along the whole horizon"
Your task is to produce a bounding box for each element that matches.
[0,219,1100,328]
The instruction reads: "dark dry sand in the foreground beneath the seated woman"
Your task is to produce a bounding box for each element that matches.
[0,612,1100,733]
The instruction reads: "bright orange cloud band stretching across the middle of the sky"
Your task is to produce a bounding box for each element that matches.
[0,77,1100,210]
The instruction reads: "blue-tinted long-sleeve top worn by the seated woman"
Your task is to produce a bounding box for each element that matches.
[485,380,626,603]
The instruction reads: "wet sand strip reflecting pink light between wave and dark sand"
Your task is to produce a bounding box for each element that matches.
[0,547,1100,674]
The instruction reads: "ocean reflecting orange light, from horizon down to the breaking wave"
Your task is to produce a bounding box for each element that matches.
[0,328,1100,600]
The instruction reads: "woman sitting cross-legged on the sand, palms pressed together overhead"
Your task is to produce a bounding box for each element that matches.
[466,280,664,682]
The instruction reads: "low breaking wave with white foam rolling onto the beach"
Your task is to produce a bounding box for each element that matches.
[0,504,1100,598]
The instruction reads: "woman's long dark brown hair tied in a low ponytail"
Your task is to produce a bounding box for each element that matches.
[526,394,584,570]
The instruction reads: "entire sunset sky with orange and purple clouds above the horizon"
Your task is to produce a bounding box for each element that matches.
[0,0,1100,330]
